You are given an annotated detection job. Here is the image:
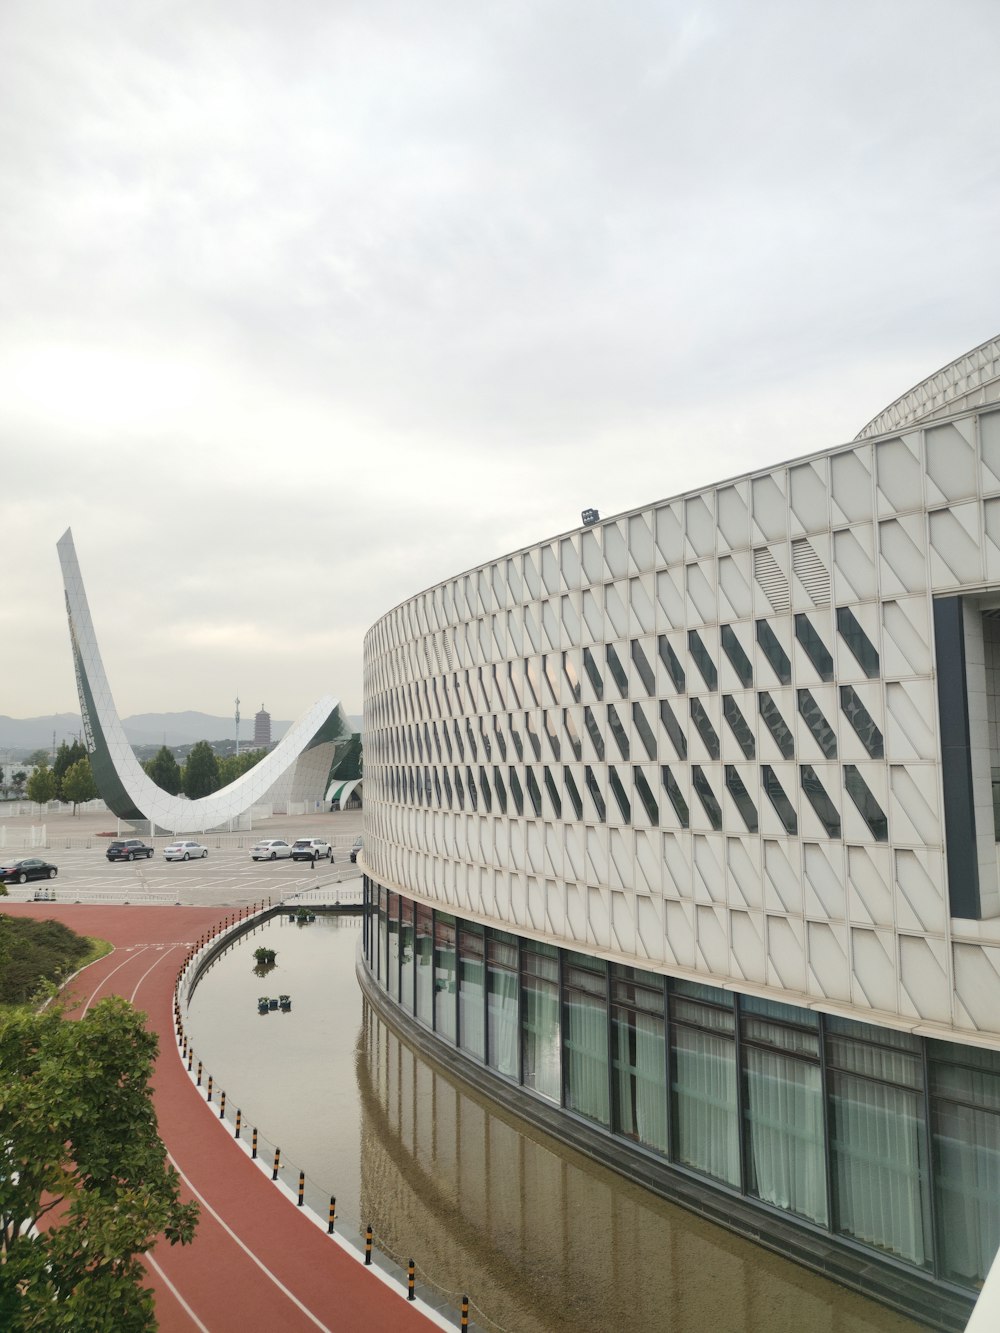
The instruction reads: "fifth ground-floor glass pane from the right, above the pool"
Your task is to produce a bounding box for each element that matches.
[611,962,669,1156]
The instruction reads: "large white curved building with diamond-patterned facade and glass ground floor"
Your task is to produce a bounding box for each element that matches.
[363,340,1000,1328]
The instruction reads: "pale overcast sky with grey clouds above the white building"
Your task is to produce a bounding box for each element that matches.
[0,0,1000,734]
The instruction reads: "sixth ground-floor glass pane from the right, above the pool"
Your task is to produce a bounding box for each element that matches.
[563,952,611,1125]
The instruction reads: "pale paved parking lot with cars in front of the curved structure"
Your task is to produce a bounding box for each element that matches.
[0,810,363,906]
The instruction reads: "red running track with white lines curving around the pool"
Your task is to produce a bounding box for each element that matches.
[0,902,436,1333]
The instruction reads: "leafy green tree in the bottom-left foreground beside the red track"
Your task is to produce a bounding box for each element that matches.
[0,996,197,1333]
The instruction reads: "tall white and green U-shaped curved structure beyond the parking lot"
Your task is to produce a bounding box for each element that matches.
[56,528,351,833]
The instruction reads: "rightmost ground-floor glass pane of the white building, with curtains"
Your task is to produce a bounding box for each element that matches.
[927,1041,1000,1288]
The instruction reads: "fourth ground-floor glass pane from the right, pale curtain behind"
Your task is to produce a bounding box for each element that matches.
[671,998,740,1185]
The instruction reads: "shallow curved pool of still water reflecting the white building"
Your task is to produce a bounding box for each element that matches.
[187,917,916,1333]
